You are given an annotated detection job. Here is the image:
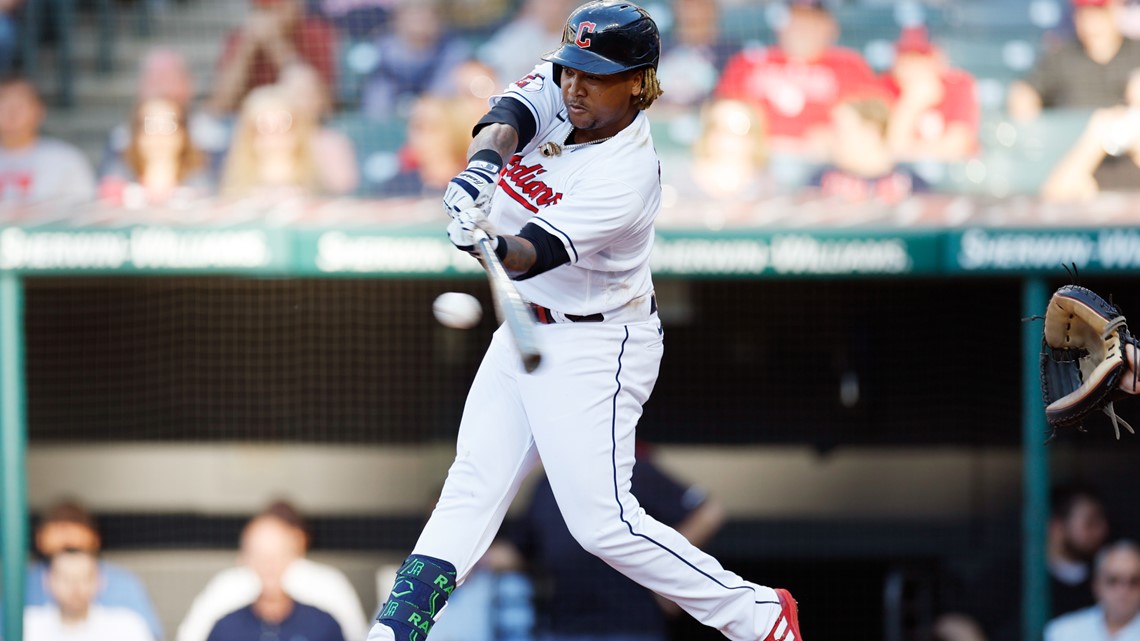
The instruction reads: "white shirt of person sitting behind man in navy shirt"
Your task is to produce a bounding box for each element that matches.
[177,559,368,641]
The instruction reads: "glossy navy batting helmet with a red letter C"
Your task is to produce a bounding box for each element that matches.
[543,0,661,82]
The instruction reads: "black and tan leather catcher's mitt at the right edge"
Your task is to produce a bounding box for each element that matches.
[1041,285,1140,439]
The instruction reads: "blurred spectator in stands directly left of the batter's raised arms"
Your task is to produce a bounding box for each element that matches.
[378,96,471,196]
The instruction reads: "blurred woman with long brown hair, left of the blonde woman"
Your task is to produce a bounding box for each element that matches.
[99,98,211,209]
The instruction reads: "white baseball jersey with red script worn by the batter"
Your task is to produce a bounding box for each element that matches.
[488,63,661,315]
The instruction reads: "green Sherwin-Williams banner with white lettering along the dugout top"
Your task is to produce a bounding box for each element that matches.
[0,226,1140,278]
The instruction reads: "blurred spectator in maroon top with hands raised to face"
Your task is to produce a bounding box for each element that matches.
[211,0,336,113]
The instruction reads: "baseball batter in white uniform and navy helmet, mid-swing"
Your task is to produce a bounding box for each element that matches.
[368,0,800,641]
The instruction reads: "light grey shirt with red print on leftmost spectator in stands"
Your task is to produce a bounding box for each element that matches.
[0,138,96,204]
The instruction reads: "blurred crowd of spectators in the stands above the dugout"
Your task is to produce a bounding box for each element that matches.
[0,0,1140,214]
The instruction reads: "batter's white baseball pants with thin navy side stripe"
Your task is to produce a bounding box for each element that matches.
[371,315,780,641]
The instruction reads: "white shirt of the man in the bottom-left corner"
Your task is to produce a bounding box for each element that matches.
[24,606,154,641]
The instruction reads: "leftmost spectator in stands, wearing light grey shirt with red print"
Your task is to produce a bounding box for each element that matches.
[0,78,95,204]
